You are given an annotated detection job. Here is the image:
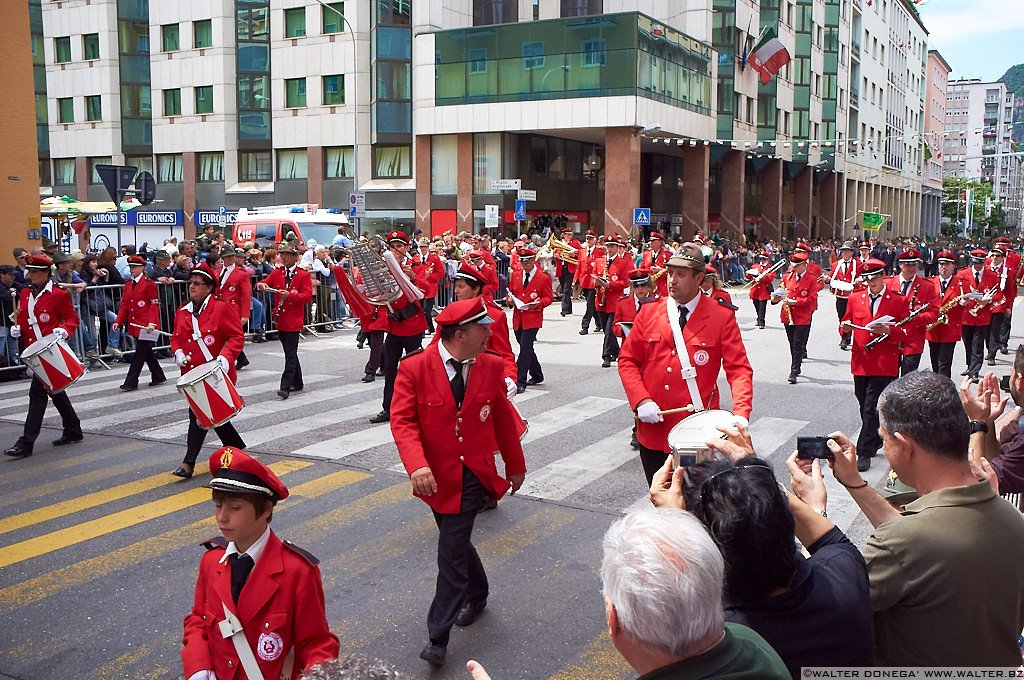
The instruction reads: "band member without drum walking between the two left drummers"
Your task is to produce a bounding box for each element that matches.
[111,255,165,392]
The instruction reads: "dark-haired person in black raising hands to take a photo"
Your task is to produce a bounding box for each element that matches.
[650,446,874,678]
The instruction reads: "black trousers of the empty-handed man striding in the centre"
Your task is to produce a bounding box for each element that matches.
[427,466,489,645]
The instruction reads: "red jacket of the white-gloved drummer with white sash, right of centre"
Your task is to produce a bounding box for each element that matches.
[618,295,754,451]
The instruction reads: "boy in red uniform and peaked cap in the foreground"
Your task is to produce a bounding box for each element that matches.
[181,447,340,680]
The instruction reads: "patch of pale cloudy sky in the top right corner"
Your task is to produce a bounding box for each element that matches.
[918,0,1024,81]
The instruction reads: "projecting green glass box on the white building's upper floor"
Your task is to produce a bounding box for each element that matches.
[435,12,713,114]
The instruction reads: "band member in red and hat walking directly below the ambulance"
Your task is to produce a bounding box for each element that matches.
[256,241,313,399]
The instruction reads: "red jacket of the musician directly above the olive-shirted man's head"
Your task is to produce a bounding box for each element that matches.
[840,289,910,376]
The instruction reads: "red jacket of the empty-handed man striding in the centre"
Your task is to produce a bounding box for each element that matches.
[391,344,526,514]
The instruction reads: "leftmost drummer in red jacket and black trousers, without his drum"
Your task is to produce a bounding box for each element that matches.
[3,254,83,458]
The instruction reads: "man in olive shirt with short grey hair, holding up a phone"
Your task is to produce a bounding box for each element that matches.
[829,372,1024,667]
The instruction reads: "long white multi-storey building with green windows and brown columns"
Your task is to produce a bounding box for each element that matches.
[30,0,926,244]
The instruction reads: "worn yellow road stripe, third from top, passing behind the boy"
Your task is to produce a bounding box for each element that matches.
[0,466,370,607]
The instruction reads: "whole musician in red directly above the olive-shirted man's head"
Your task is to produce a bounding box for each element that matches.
[840,258,910,472]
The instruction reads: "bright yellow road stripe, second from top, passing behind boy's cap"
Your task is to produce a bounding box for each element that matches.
[0,461,312,568]
